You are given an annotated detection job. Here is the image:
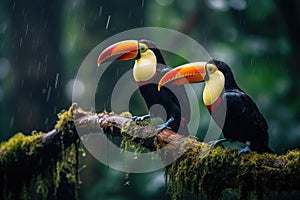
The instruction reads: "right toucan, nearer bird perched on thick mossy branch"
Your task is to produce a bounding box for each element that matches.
[158,59,272,154]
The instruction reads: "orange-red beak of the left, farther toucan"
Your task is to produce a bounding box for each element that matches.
[97,40,139,66]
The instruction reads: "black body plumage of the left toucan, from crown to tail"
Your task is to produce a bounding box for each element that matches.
[137,40,190,135]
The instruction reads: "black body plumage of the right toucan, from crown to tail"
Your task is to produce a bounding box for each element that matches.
[209,60,272,152]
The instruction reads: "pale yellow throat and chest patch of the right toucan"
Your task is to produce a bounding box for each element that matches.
[203,71,225,106]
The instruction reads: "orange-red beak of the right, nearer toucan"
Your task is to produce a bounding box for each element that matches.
[158,62,207,91]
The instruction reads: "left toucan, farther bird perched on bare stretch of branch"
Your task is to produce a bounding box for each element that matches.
[98,39,190,135]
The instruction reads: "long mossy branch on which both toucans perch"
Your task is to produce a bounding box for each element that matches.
[0,104,300,199]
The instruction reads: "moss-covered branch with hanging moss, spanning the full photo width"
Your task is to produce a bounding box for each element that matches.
[0,106,300,199]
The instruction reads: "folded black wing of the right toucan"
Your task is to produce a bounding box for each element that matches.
[223,90,269,151]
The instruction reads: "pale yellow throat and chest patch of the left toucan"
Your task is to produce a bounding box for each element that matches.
[133,51,157,82]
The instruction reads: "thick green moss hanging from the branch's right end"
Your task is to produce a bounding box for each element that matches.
[166,145,300,199]
